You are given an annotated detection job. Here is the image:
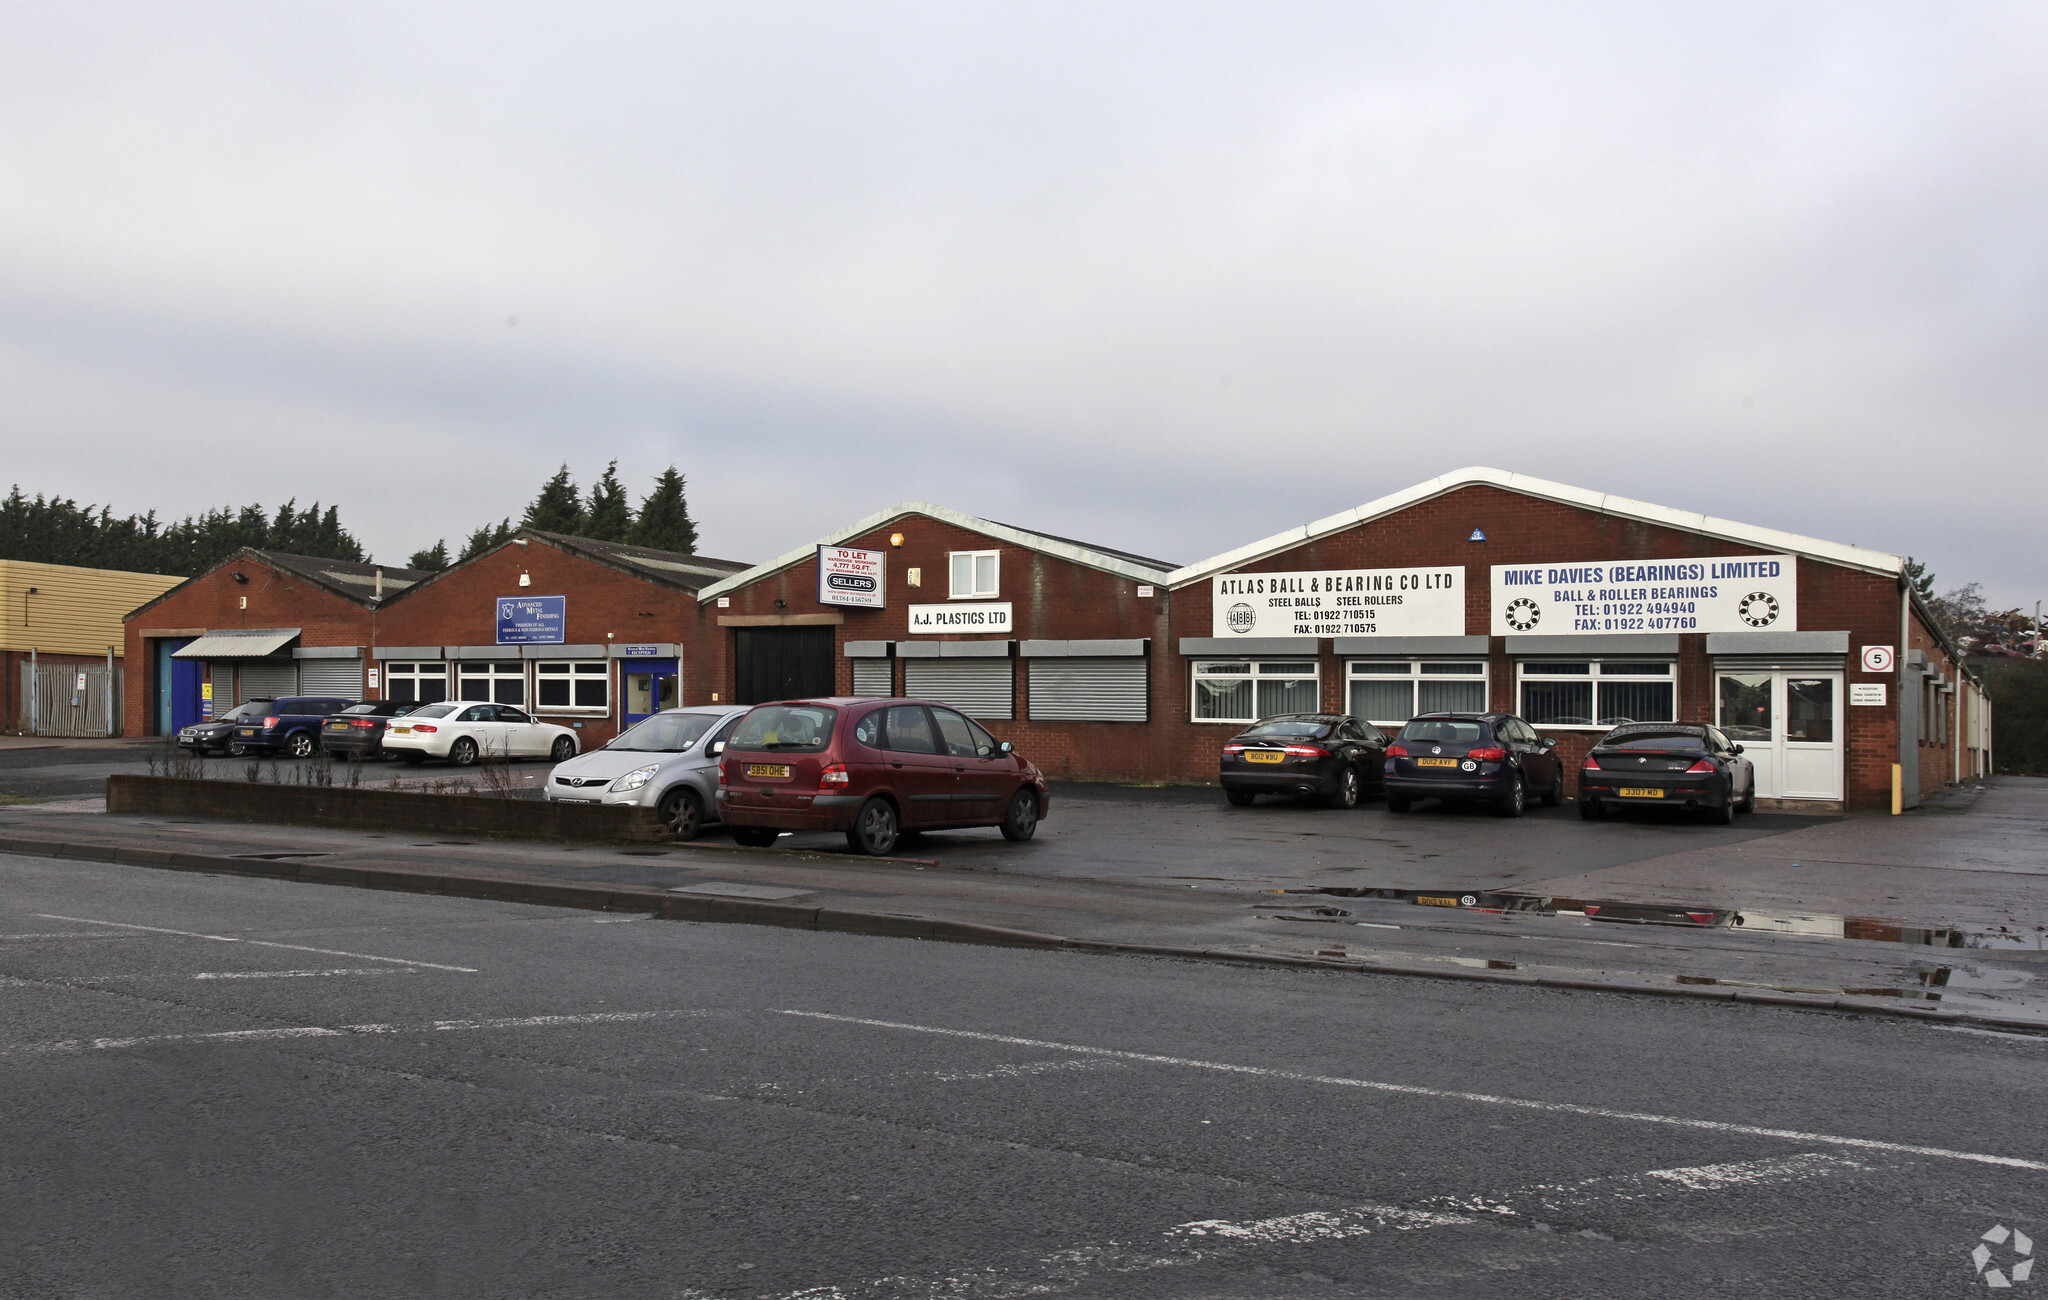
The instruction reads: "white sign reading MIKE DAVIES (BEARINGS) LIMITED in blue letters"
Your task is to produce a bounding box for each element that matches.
[1493,555,1798,637]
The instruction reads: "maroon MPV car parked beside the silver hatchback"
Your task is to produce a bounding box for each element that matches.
[719,698,1051,854]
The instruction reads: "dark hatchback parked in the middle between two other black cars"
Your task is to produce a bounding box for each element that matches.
[1386,712,1565,817]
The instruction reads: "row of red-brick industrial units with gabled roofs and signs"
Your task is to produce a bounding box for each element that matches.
[129,469,1991,809]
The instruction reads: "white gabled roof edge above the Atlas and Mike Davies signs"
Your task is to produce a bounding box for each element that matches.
[1165,467,1905,588]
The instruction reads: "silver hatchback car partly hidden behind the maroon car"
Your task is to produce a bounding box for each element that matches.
[547,704,752,839]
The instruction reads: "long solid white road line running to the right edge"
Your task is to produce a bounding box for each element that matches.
[782,1009,2048,1173]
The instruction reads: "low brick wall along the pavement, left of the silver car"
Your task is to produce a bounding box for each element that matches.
[106,776,670,843]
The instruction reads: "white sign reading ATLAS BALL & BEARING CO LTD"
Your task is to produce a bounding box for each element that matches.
[1208,567,1464,637]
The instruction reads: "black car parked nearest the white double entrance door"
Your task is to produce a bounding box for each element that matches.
[1579,723,1757,825]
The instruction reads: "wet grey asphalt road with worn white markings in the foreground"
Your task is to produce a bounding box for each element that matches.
[0,858,2048,1300]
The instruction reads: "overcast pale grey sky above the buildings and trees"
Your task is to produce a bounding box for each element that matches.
[0,0,2048,604]
